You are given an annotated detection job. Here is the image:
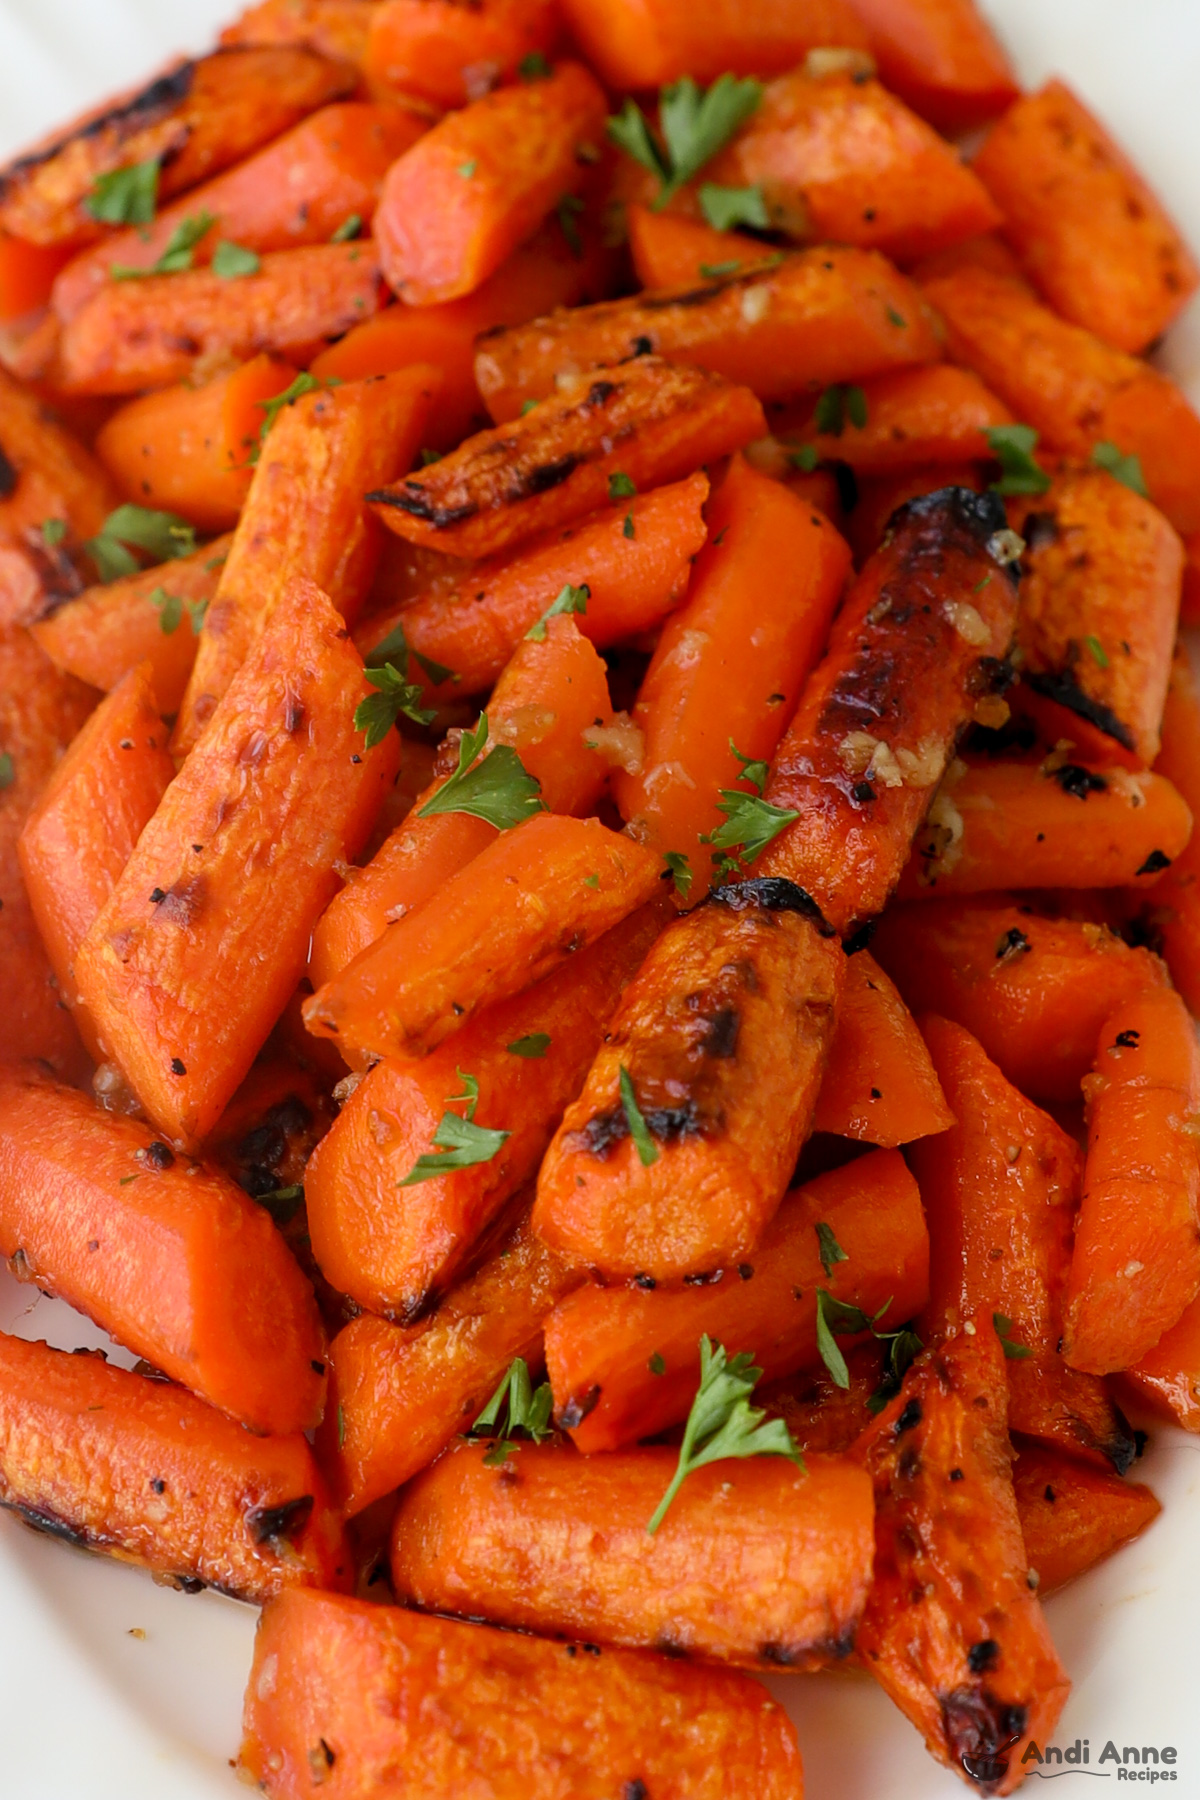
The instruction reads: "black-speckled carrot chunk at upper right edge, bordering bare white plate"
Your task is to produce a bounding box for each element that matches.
[973,81,1200,351]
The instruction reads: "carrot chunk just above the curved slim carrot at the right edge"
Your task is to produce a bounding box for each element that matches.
[871,896,1166,1101]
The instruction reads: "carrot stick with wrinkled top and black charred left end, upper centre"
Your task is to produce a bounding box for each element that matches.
[367,356,766,558]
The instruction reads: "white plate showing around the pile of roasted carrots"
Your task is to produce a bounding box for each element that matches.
[0,0,1200,1800]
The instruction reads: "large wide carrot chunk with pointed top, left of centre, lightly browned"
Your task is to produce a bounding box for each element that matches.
[76,580,398,1148]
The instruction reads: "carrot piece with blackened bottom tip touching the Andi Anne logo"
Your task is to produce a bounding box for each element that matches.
[855,1318,1070,1795]
